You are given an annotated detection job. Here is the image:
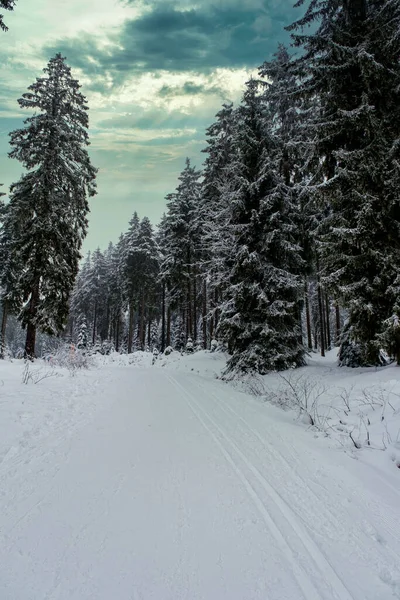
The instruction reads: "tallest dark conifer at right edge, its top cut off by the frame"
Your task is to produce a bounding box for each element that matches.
[290,0,400,366]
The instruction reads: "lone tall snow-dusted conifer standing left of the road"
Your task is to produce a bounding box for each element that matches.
[8,54,96,357]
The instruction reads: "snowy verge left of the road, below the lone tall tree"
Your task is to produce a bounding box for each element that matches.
[0,355,104,472]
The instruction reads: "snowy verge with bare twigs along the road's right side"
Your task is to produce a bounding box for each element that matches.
[152,350,400,477]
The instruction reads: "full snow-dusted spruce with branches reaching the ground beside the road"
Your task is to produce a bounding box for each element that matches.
[218,80,304,373]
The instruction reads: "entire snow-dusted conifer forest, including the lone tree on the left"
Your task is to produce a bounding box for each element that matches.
[0,0,400,376]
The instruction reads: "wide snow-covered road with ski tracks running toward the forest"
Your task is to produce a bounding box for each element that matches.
[0,367,400,600]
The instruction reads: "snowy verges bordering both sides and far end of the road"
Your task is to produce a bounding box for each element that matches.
[0,351,400,488]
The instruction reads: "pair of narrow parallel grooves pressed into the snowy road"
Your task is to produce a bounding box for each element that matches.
[165,373,354,600]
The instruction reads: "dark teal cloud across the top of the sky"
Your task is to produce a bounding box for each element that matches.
[43,0,297,92]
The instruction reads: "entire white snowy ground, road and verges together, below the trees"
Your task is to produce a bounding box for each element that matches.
[0,353,400,600]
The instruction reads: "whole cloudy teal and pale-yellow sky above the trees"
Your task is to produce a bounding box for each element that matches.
[0,0,302,250]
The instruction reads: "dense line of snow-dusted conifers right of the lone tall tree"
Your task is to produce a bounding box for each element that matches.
[2,0,400,373]
